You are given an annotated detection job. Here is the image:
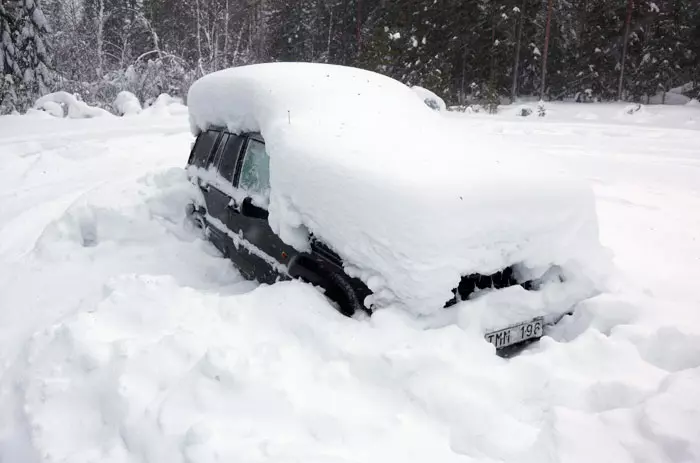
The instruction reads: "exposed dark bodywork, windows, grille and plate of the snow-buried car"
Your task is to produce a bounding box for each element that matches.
[186,127,576,349]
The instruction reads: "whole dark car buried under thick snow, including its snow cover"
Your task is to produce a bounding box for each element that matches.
[187,63,602,349]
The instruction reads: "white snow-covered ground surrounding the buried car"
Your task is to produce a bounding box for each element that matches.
[0,104,700,463]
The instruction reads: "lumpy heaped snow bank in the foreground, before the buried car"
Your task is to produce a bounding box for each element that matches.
[18,275,700,463]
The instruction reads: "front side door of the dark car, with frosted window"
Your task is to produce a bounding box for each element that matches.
[228,134,297,283]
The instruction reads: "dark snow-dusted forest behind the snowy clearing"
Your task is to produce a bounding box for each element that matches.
[0,0,700,114]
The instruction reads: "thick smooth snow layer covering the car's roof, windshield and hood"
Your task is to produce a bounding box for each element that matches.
[188,63,604,320]
